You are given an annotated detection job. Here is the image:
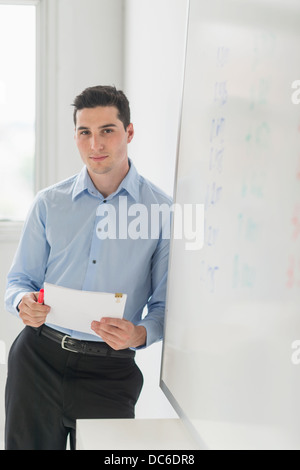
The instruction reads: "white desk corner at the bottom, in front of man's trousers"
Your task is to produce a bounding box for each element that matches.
[76,418,199,450]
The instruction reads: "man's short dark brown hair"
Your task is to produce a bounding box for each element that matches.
[72,85,130,130]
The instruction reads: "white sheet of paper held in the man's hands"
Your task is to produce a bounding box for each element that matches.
[44,282,127,335]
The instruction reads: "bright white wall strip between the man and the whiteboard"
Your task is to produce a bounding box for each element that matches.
[124,0,187,418]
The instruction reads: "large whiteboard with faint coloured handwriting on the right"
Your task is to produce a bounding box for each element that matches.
[161,0,300,449]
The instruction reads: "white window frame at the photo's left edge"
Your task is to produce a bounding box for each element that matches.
[0,0,58,237]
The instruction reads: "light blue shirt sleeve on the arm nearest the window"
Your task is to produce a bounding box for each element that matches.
[5,194,49,315]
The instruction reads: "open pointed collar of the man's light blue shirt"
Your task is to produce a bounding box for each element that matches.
[72,159,139,202]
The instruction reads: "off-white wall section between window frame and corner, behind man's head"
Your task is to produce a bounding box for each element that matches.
[56,0,124,183]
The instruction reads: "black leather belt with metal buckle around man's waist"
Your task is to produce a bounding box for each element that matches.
[40,325,135,358]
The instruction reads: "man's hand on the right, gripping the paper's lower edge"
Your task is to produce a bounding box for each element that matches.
[91,317,147,351]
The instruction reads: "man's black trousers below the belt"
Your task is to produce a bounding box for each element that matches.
[5,327,143,450]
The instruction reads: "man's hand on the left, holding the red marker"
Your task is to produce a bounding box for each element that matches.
[18,292,50,328]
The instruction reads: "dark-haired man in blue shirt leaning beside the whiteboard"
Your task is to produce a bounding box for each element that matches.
[5,86,171,450]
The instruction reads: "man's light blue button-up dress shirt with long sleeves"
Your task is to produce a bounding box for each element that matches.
[5,162,172,346]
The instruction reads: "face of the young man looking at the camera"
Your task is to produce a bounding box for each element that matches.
[75,106,134,177]
